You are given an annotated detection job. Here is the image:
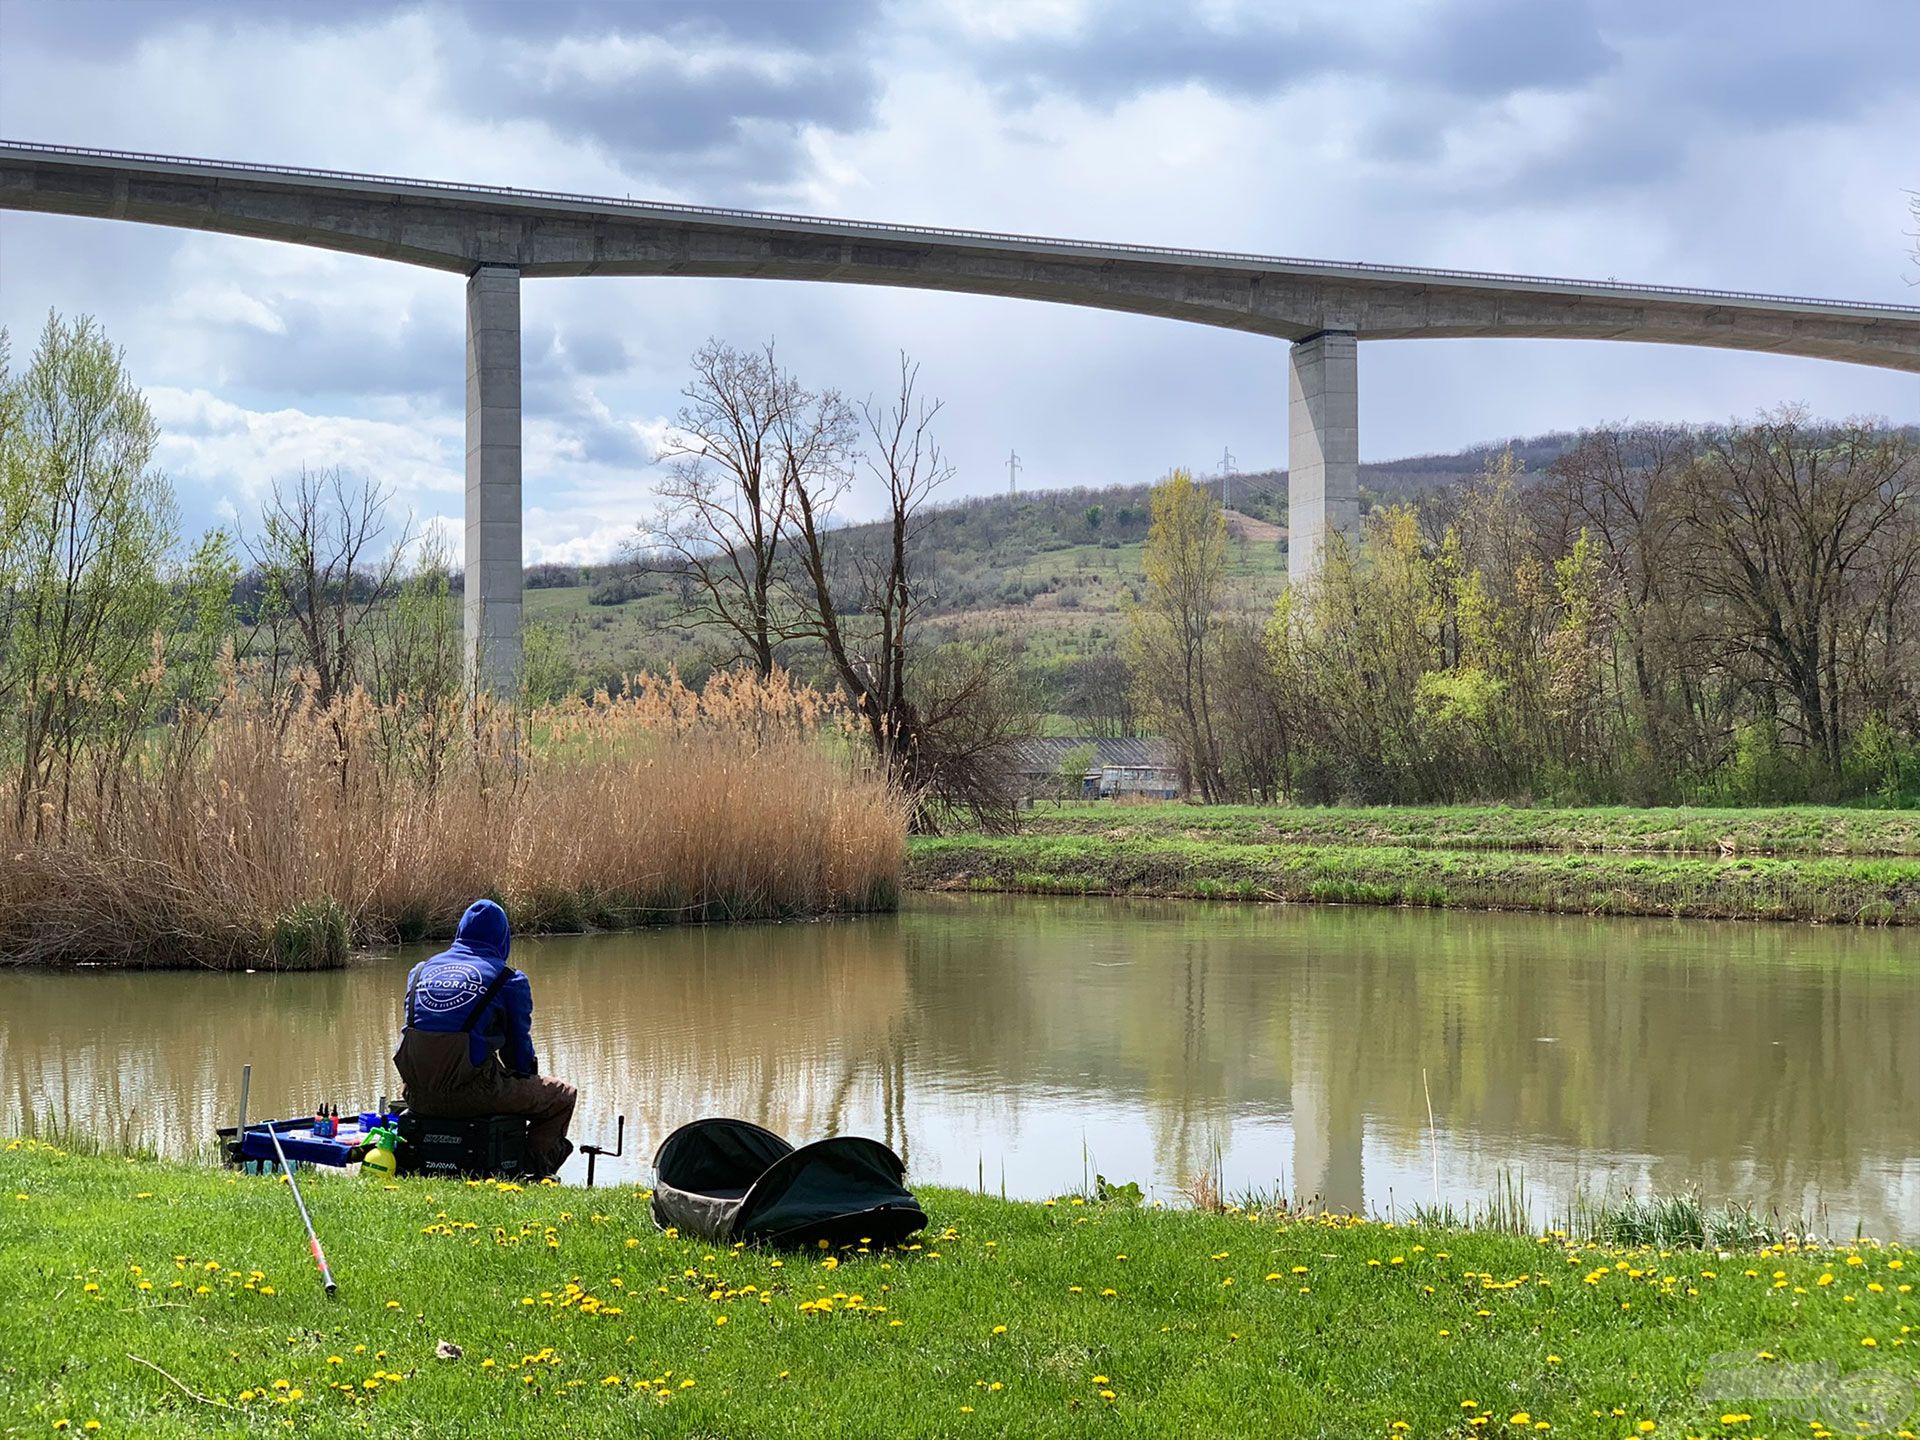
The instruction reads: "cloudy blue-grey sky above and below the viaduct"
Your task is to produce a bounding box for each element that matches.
[0,0,1920,563]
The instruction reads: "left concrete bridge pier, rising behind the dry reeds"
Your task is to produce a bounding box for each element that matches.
[467,265,522,695]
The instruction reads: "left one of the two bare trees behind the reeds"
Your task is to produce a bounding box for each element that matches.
[636,340,852,674]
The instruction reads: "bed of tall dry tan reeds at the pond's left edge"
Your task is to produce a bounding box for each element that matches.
[0,674,906,968]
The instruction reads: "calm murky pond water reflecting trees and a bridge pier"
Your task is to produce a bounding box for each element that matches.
[0,897,1920,1238]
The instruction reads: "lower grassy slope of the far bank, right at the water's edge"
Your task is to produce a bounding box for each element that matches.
[906,833,1920,924]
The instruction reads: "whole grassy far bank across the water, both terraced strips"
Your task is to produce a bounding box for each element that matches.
[906,804,1920,925]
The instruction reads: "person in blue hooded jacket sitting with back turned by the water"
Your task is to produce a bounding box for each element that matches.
[394,900,576,1175]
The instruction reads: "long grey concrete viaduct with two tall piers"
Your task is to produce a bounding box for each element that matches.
[11,142,1920,684]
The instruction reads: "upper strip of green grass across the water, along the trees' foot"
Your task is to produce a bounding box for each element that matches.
[1023,804,1920,856]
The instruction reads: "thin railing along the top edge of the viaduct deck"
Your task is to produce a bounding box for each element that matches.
[11,140,1920,315]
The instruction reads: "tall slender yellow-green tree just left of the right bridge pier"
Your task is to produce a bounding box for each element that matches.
[1127,480,1227,804]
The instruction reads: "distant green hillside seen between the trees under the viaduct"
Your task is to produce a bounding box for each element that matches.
[526,432,1576,695]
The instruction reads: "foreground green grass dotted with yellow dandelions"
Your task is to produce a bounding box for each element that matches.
[0,1142,1920,1436]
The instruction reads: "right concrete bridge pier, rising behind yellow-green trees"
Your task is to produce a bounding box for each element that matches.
[1286,330,1359,584]
